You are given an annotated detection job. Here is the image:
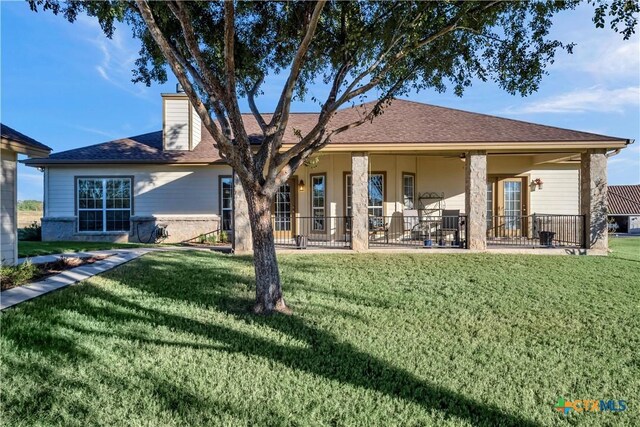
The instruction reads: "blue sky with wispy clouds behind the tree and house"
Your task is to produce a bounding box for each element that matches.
[0,2,640,200]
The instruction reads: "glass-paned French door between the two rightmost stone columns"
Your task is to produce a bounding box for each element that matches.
[487,177,529,237]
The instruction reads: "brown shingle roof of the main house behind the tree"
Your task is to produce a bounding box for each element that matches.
[25,99,624,164]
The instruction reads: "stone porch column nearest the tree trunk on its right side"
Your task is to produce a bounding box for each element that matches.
[351,153,369,252]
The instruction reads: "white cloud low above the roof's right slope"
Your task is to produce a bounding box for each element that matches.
[503,86,640,114]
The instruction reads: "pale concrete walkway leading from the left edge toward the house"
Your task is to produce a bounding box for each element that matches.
[0,246,226,310]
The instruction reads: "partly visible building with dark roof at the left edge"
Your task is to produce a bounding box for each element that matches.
[0,124,51,265]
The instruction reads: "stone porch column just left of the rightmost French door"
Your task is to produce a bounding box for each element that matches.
[464,151,487,250]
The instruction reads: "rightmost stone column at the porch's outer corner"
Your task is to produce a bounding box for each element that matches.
[580,149,609,250]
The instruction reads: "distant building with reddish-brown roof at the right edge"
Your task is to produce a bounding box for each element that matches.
[607,185,640,234]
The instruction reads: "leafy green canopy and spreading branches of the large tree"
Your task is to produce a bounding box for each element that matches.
[30,0,638,190]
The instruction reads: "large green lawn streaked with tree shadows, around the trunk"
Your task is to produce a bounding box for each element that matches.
[0,247,640,426]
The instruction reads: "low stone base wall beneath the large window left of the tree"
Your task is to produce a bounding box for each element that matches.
[42,215,220,243]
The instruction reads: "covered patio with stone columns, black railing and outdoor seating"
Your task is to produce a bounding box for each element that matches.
[236,149,607,251]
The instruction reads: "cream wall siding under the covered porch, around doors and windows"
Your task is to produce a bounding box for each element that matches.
[296,154,580,216]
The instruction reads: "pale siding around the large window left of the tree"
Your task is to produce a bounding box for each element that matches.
[47,165,232,217]
